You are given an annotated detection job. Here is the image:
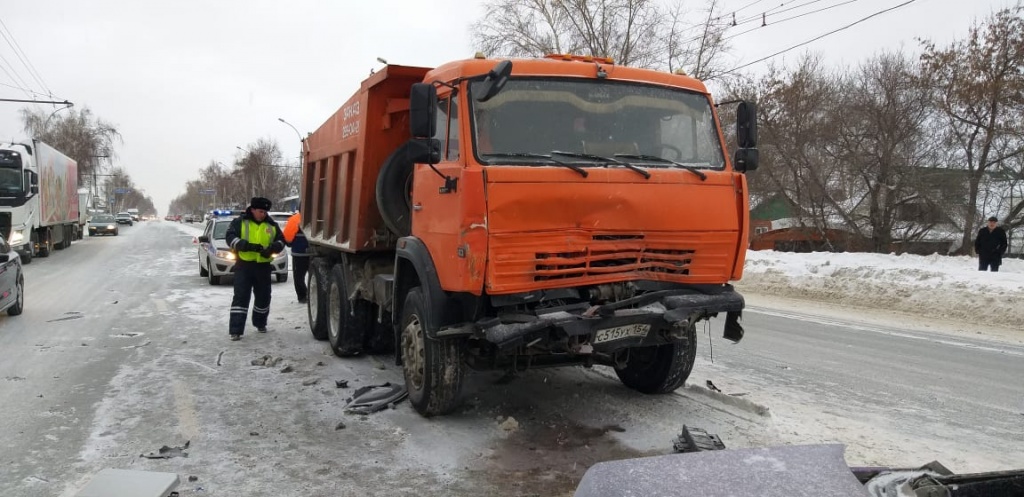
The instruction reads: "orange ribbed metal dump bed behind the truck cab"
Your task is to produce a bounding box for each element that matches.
[301,66,430,252]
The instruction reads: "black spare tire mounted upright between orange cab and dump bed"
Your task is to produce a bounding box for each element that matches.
[377,139,440,237]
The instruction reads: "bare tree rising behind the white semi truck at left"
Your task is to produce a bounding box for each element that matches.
[20,108,121,180]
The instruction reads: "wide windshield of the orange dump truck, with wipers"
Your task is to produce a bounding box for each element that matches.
[468,78,725,169]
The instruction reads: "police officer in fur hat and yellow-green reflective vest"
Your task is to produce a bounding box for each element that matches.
[225,197,285,340]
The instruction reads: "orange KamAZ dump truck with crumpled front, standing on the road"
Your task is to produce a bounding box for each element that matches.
[301,55,758,416]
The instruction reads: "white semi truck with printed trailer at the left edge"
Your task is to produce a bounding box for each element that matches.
[0,139,81,263]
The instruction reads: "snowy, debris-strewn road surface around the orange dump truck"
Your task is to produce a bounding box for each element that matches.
[0,222,1024,497]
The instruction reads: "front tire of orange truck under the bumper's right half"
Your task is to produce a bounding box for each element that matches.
[615,325,697,394]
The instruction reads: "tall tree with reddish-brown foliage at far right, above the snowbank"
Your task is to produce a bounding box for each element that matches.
[922,4,1024,253]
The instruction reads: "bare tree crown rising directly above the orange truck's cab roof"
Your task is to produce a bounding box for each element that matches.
[472,0,728,79]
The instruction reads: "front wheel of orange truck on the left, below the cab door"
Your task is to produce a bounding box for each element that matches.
[400,287,466,417]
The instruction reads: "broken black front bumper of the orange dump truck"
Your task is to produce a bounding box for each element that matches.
[448,285,744,353]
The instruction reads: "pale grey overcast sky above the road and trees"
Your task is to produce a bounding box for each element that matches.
[0,0,1014,213]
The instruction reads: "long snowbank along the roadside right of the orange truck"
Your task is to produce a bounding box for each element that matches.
[736,250,1024,329]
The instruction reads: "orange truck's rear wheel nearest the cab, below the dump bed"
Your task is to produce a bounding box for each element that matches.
[327,263,374,358]
